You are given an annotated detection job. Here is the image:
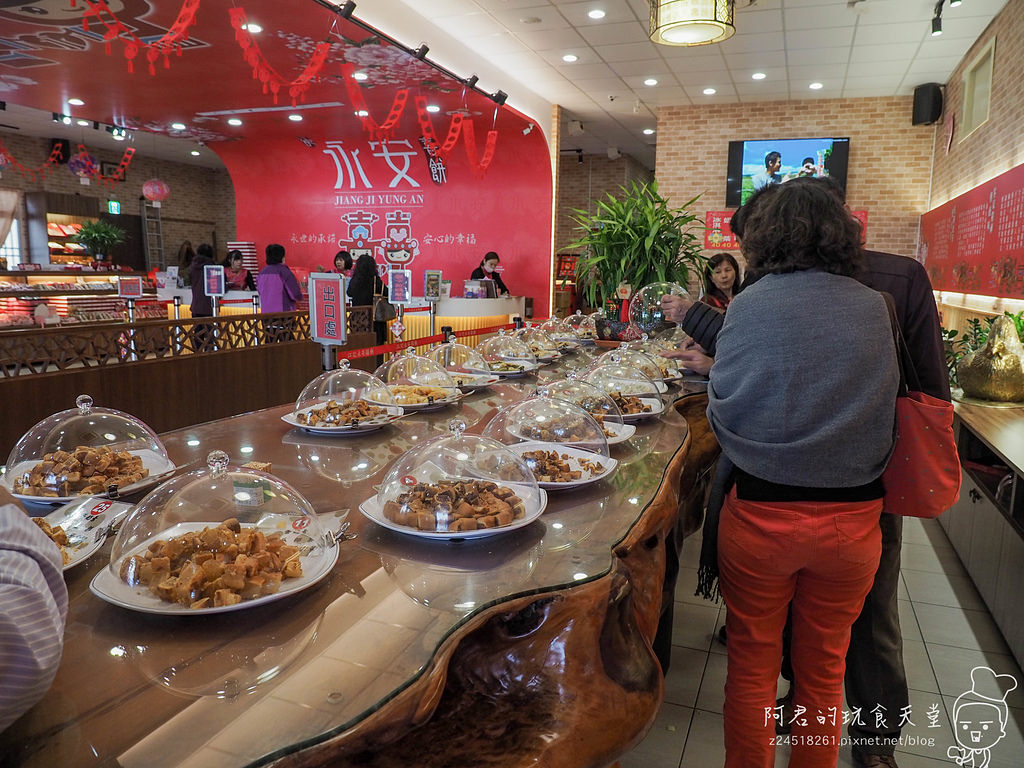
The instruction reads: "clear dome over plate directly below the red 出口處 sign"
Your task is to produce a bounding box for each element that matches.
[285,359,402,432]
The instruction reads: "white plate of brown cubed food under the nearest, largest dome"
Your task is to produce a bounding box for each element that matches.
[89,518,338,615]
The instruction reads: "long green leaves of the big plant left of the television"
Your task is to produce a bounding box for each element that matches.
[569,181,705,319]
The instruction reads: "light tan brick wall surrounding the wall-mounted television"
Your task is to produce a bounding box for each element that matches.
[655,96,935,256]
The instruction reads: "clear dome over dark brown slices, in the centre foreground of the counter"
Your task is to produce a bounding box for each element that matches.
[360,420,547,538]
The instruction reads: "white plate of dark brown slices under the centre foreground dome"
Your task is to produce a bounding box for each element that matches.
[359,478,548,540]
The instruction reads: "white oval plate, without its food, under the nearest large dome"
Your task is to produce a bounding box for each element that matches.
[89,522,338,616]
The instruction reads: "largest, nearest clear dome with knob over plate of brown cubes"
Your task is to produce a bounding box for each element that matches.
[92,451,338,613]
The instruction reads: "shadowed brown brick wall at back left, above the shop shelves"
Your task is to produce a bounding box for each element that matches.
[0,132,236,263]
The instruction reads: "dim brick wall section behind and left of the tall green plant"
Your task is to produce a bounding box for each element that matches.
[555,153,652,253]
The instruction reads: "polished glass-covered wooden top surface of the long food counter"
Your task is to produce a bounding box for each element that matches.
[0,351,712,768]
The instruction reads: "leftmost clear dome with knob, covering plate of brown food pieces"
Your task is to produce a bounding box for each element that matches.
[3,394,174,502]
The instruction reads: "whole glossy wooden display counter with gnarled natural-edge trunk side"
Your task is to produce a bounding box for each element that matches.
[0,360,717,768]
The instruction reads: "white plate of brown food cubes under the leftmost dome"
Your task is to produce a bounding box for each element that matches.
[0,445,175,504]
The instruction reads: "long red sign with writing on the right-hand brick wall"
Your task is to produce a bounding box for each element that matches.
[918,165,1024,298]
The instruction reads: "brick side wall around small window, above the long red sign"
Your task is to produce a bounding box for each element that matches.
[928,0,1024,209]
